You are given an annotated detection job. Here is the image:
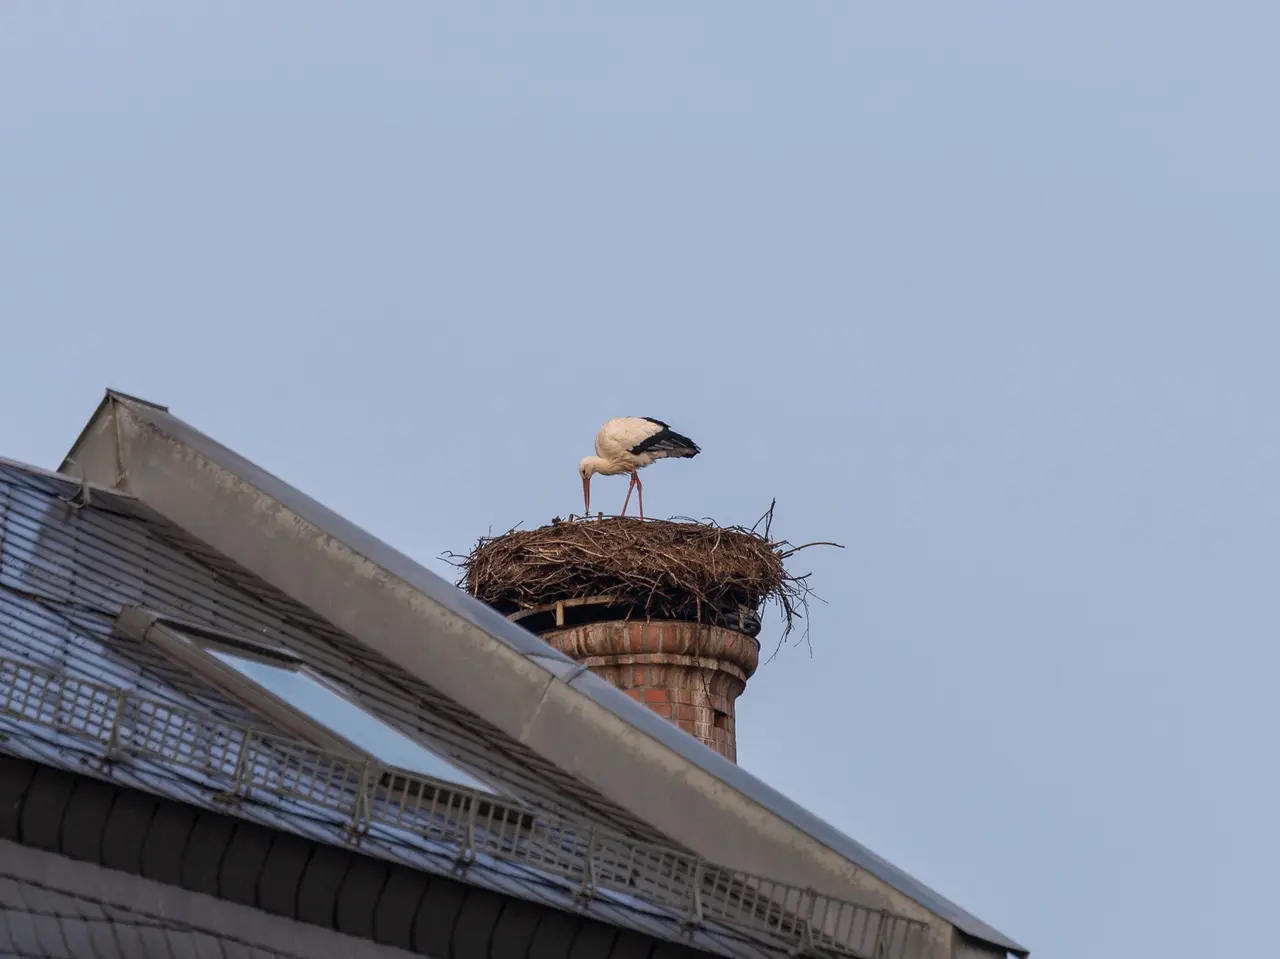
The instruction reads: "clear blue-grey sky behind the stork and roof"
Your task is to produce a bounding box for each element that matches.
[0,0,1280,959]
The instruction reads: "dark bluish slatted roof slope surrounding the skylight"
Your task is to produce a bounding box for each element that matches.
[0,460,819,959]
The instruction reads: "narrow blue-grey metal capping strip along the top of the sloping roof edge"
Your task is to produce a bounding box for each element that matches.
[85,391,1028,954]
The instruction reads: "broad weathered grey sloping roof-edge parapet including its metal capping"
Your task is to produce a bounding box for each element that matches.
[57,393,1027,955]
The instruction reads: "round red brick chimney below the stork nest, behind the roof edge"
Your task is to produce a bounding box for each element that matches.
[541,622,760,762]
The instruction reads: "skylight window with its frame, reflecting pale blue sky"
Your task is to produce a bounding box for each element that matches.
[116,607,497,795]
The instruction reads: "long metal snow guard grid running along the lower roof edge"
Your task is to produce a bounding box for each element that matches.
[0,657,928,959]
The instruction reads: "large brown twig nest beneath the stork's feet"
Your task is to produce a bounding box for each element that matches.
[443,501,842,652]
